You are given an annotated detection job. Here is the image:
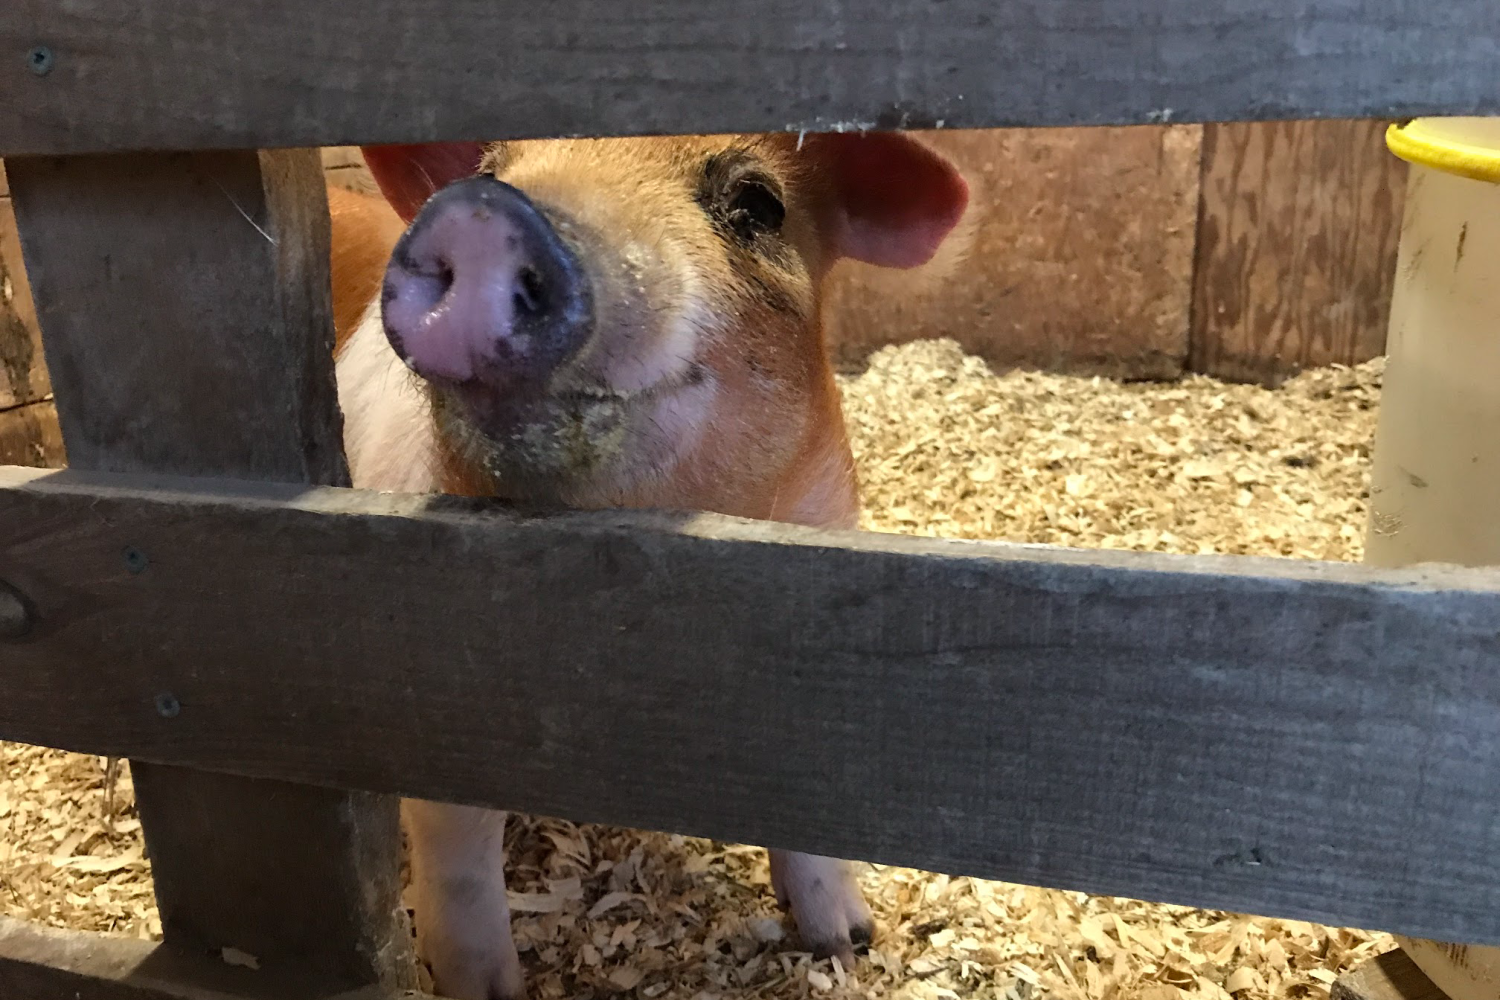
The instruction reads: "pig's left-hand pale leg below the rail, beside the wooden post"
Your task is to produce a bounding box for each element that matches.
[402,799,527,1000]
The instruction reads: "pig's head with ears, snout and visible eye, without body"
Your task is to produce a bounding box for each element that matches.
[366,133,968,516]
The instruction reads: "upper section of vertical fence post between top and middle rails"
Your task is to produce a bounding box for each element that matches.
[8,151,348,484]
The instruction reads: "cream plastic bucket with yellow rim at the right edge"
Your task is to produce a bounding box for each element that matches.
[1365,118,1500,1000]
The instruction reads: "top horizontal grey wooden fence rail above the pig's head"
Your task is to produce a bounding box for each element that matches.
[0,0,1500,156]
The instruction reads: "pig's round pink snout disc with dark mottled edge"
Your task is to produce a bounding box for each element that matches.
[381,177,593,391]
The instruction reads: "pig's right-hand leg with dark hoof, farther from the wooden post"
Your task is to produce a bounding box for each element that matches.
[771,850,875,967]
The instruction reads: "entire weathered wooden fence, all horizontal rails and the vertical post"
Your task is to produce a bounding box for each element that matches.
[0,0,1500,1000]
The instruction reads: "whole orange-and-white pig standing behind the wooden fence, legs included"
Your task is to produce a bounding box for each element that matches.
[330,132,969,1000]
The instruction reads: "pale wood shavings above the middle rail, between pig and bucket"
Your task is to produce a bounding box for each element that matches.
[843,340,1383,561]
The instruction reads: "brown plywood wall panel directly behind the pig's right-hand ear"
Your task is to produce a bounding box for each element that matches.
[825,126,1200,378]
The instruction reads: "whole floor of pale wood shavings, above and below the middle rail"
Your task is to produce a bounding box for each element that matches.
[0,342,1392,1000]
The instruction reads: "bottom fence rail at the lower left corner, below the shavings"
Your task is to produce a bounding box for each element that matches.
[0,916,428,1000]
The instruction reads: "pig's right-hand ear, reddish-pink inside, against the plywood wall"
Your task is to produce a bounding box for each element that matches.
[804,132,969,267]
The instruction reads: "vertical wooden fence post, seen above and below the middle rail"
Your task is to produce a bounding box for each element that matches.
[8,150,414,987]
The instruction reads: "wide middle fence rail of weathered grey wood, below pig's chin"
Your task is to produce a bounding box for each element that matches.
[0,469,1500,942]
